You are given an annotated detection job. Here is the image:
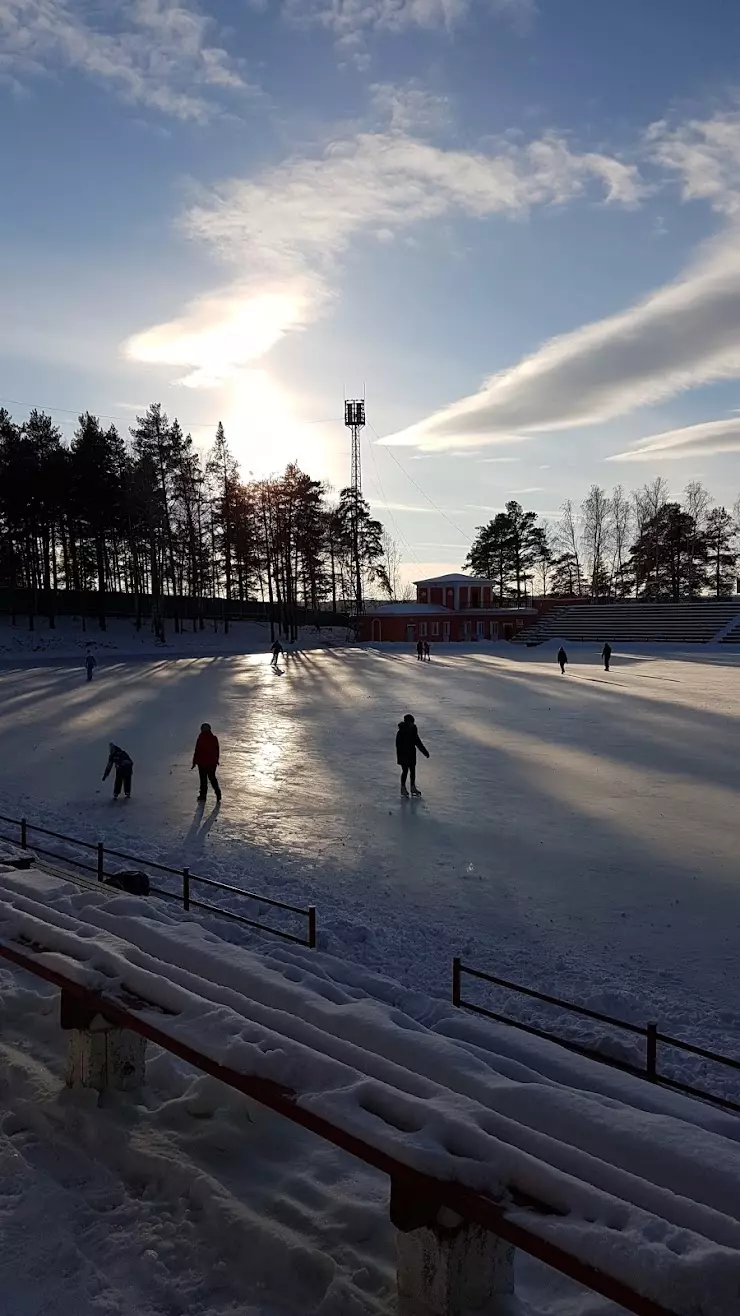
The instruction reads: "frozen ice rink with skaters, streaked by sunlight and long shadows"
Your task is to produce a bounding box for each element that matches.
[0,646,740,1041]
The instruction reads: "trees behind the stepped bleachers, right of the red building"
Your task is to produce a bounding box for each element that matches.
[465,476,740,603]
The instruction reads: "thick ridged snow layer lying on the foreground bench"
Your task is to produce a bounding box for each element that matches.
[0,871,740,1316]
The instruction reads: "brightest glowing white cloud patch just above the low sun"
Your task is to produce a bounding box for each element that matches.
[124,283,308,388]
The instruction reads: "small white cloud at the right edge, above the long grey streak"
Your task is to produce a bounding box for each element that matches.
[645,112,740,216]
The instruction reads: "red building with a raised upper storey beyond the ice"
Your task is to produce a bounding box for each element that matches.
[359,571,537,644]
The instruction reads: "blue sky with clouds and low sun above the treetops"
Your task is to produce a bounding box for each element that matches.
[0,0,740,578]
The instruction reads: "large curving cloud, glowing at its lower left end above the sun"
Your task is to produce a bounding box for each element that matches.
[128,113,640,387]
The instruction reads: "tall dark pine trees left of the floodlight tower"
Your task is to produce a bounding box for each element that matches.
[0,403,392,636]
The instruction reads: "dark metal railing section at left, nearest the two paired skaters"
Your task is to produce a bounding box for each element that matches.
[0,813,316,950]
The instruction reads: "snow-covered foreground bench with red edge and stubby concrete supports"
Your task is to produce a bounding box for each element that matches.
[0,870,740,1316]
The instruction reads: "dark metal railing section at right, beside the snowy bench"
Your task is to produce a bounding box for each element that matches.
[452,955,740,1113]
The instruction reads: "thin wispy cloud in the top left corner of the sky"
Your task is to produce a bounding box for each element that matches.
[0,0,248,122]
